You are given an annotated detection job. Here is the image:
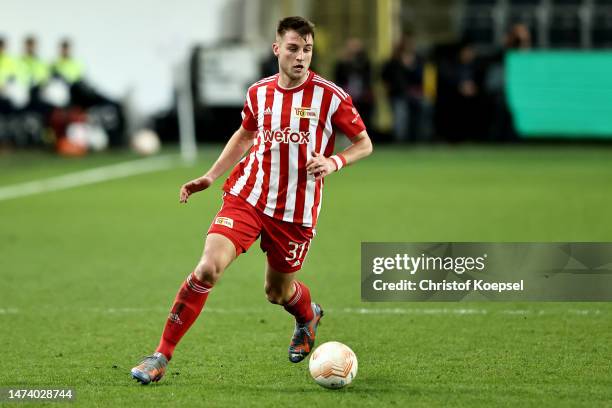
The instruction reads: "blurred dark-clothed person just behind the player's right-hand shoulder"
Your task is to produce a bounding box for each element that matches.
[334,38,374,129]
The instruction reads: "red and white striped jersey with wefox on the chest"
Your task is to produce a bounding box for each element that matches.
[223,71,365,227]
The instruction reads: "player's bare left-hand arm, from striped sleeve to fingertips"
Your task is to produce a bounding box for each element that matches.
[179,126,256,203]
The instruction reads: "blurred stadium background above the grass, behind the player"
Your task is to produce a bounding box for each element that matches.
[0,0,612,158]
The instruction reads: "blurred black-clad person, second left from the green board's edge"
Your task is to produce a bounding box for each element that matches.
[435,40,487,142]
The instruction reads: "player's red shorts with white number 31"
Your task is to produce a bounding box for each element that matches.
[208,193,314,273]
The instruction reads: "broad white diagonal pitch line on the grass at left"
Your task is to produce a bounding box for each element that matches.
[0,156,176,201]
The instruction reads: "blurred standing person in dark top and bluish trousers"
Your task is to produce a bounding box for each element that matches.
[382,34,423,142]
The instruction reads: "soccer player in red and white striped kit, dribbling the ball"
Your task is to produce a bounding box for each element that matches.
[131,17,372,384]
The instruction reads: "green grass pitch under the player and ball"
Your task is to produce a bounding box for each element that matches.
[0,146,612,407]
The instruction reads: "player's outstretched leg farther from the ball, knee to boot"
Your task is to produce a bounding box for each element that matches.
[131,233,237,384]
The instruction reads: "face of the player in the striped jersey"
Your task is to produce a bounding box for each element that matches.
[272,31,314,81]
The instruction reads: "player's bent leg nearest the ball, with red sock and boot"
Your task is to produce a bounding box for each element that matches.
[265,262,323,363]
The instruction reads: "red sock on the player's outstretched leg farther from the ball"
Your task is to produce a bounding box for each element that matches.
[155,272,212,360]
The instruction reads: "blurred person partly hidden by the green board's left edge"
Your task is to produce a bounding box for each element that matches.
[485,24,531,142]
